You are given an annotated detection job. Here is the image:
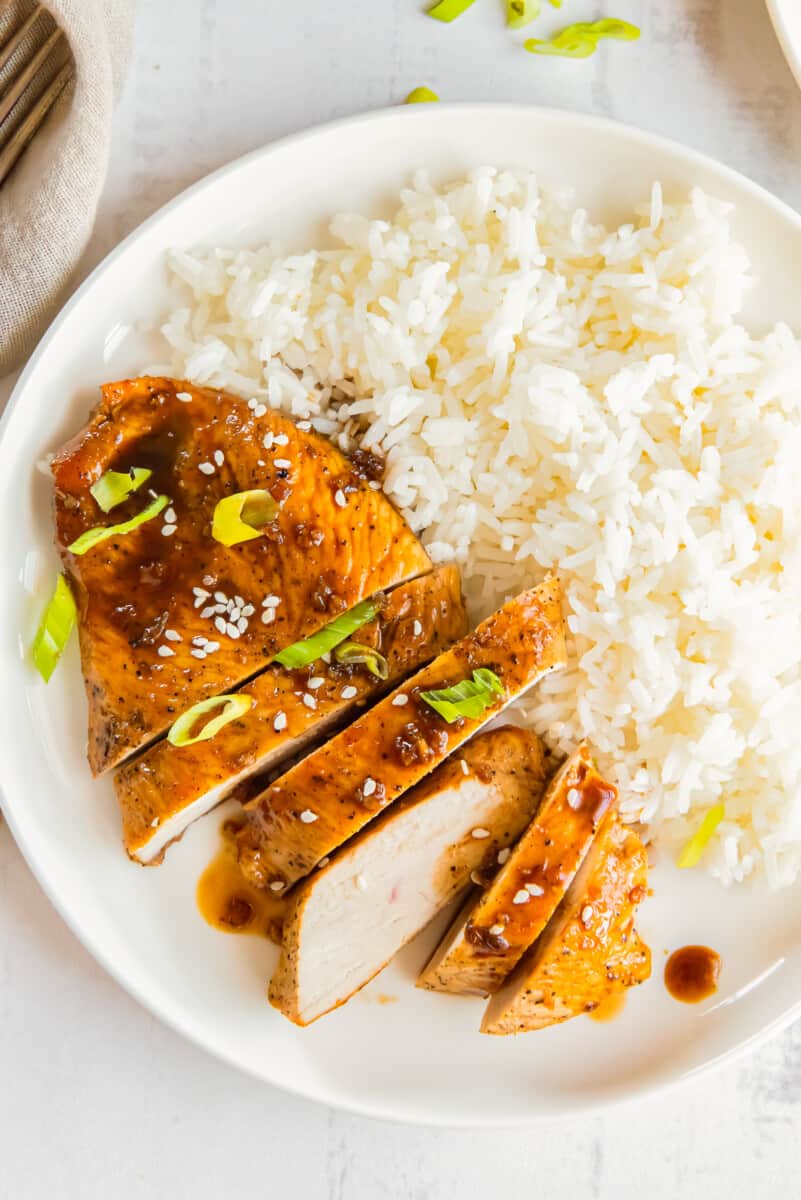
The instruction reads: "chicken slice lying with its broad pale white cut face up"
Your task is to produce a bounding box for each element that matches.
[270,726,546,1025]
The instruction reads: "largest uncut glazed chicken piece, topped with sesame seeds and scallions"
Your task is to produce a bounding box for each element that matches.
[53,378,430,774]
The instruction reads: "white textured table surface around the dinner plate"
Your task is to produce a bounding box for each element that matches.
[0,0,801,1200]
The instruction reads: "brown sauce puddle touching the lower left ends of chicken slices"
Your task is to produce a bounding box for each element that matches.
[197,820,287,942]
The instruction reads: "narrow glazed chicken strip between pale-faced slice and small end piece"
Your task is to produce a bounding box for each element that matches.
[417,745,618,996]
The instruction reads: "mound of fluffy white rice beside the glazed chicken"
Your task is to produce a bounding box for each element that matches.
[158,168,801,887]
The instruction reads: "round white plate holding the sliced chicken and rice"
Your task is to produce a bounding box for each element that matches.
[0,106,801,1126]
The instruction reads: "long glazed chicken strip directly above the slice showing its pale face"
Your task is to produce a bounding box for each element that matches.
[239,580,565,890]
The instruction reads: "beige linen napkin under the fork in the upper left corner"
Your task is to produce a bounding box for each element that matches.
[0,0,135,376]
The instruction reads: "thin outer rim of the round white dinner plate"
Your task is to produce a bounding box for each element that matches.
[0,105,801,1129]
